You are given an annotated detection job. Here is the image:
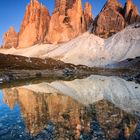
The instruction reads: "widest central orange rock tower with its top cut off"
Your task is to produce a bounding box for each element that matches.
[45,0,86,44]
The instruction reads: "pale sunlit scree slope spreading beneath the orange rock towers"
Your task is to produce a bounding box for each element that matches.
[0,24,140,67]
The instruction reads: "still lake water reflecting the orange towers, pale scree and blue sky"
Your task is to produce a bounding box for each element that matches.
[0,76,140,140]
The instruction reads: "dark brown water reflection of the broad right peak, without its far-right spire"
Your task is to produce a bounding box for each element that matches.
[95,101,124,139]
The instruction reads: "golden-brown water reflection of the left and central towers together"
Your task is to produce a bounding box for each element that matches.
[3,88,87,136]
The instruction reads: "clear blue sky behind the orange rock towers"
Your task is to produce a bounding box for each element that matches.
[0,0,140,45]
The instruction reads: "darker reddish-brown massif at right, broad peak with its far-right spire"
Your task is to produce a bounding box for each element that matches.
[93,0,140,38]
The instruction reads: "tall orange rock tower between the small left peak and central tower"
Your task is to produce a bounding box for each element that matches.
[18,0,50,48]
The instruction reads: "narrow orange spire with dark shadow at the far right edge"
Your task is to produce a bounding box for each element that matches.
[124,0,140,24]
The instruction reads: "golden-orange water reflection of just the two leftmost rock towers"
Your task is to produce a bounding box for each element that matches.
[3,88,49,134]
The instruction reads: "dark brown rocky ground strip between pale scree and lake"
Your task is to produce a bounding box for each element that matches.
[0,54,140,86]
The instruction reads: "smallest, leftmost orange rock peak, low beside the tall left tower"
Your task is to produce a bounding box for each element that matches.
[2,27,18,49]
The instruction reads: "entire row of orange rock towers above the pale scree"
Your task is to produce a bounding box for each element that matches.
[2,0,140,48]
